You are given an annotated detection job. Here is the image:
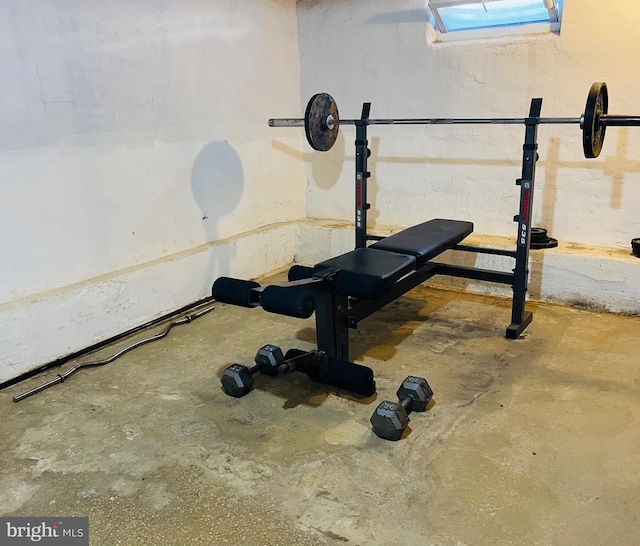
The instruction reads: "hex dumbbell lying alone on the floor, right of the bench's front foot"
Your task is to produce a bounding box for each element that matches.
[370,375,433,441]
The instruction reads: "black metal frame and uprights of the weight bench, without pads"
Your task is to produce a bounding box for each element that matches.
[214,98,542,396]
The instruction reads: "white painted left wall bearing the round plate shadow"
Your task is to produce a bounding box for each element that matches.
[0,0,305,381]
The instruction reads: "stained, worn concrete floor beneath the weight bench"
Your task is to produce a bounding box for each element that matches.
[0,272,640,546]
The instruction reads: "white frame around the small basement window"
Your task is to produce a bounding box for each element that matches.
[428,0,563,37]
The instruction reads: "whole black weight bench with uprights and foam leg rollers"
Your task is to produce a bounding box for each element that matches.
[213,98,542,396]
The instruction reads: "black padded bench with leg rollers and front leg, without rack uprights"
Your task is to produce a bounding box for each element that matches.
[213,219,473,396]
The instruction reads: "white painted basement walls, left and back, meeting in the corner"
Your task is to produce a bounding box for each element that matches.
[0,0,640,381]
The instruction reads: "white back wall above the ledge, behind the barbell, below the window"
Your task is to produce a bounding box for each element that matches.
[294,0,640,249]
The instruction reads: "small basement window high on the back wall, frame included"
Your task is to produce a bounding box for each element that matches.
[429,0,563,39]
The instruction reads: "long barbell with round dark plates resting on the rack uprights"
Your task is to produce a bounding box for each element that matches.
[269,82,640,158]
